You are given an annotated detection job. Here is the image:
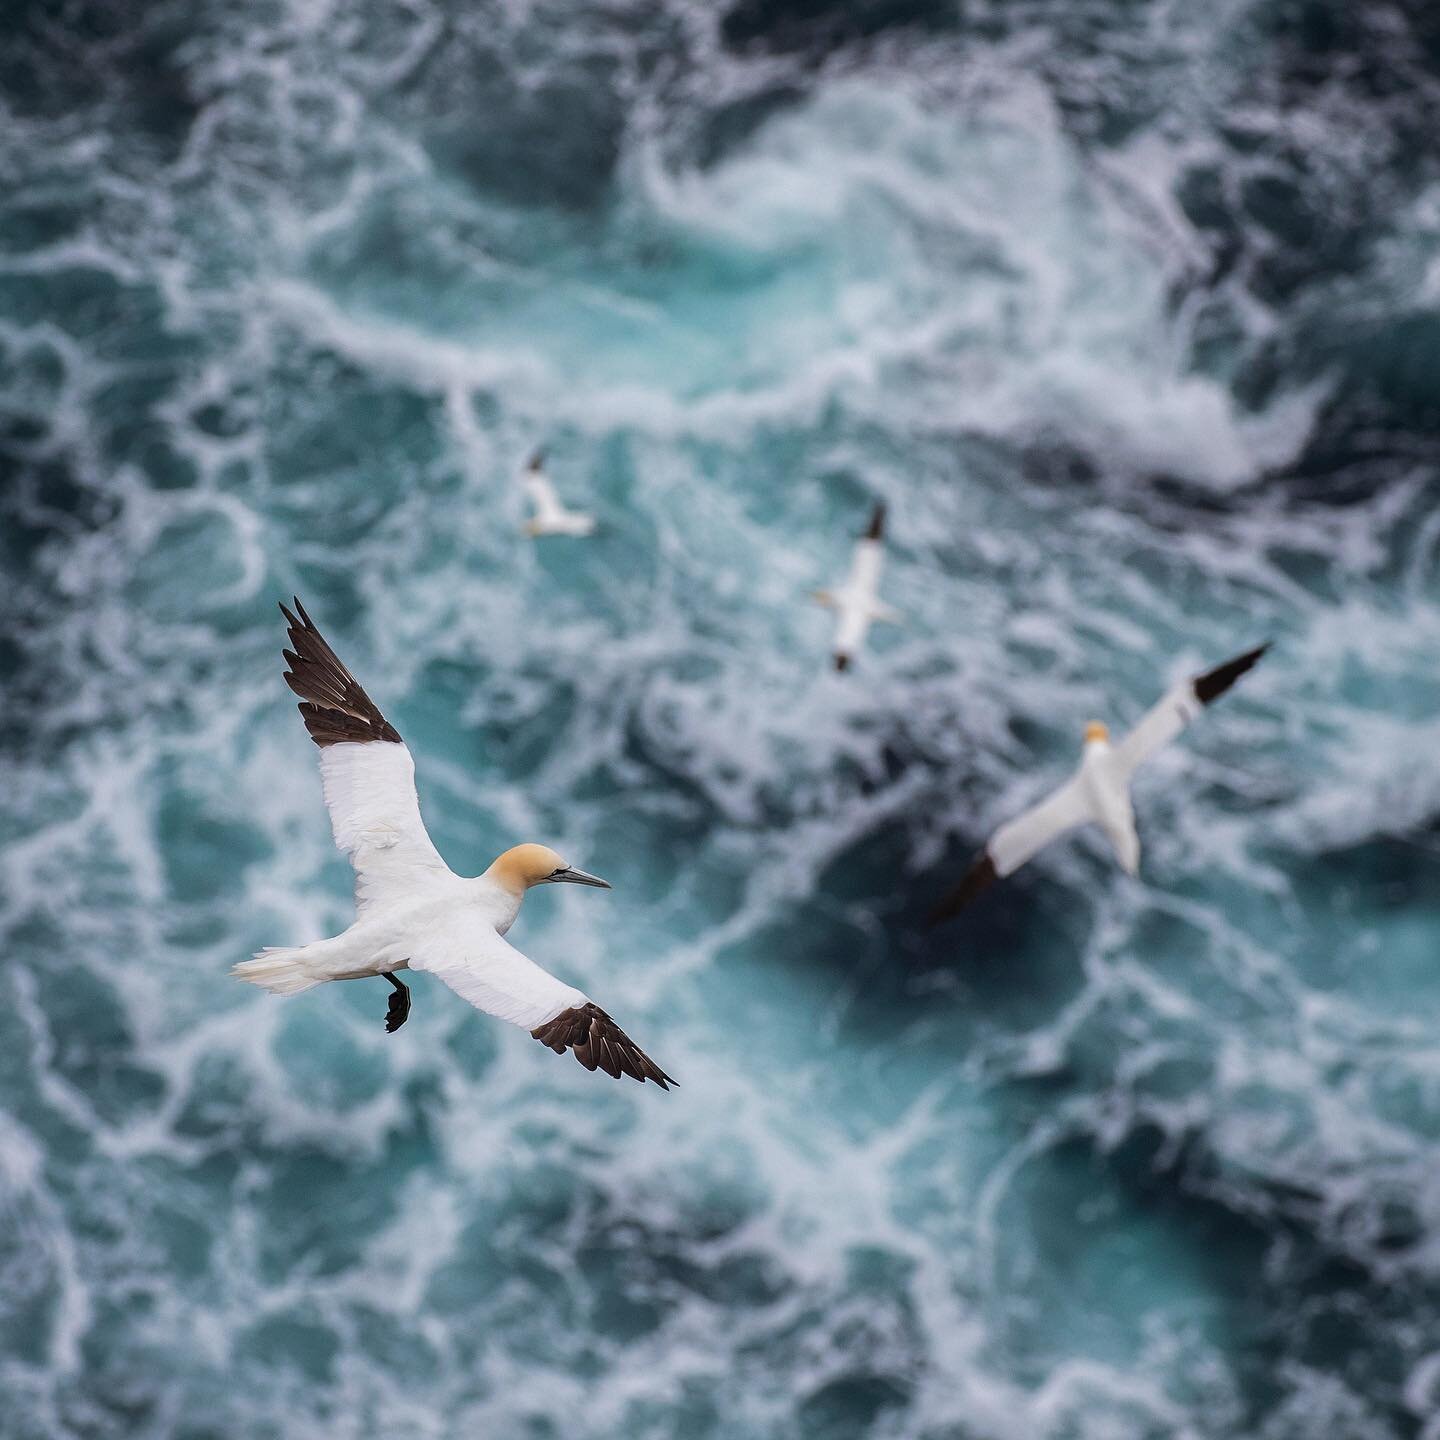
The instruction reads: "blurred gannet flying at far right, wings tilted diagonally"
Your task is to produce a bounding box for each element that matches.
[929,644,1270,924]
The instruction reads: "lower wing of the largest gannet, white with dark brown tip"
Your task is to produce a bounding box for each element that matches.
[410,922,675,1090]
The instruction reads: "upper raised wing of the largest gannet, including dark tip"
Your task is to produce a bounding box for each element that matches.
[281,599,449,910]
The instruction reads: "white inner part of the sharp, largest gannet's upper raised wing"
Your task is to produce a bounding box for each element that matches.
[320,742,451,910]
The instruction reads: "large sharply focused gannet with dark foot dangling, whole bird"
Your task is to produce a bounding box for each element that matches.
[230,599,675,1090]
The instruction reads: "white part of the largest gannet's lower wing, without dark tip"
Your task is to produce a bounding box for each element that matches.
[410,910,588,1030]
